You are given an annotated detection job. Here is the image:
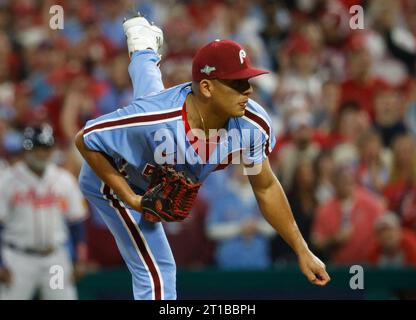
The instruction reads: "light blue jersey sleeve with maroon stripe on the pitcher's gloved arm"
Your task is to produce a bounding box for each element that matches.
[84,105,150,165]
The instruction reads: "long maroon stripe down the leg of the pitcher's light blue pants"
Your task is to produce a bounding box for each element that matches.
[103,185,162,300]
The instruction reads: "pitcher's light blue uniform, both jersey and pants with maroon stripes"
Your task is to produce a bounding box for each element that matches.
[79,50,275,299]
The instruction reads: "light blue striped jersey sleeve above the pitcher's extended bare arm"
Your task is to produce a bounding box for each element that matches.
[243,101,276,165]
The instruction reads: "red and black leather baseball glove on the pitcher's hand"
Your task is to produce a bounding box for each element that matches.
[141,165,201,222]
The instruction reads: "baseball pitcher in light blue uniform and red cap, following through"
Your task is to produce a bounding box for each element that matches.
[76,17,329,299]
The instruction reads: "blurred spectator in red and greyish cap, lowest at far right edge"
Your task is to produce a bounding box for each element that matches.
[369,212,416,267]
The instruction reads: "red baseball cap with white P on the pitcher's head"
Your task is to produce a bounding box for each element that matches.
[192,40,269,81]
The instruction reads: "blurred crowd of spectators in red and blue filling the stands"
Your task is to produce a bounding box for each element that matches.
[0,0,416,284]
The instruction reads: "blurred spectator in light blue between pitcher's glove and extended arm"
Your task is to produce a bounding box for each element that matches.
[207,165,274,269]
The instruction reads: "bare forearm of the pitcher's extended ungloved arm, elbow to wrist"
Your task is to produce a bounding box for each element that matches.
[255,178,309,255]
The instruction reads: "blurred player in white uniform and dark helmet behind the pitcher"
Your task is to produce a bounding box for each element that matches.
[0,125,86,300]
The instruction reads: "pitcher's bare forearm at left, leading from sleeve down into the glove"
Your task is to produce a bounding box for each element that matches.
[75,130,141,209]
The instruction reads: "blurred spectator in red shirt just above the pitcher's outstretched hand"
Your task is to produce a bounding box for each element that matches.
[311,162,384,265]
